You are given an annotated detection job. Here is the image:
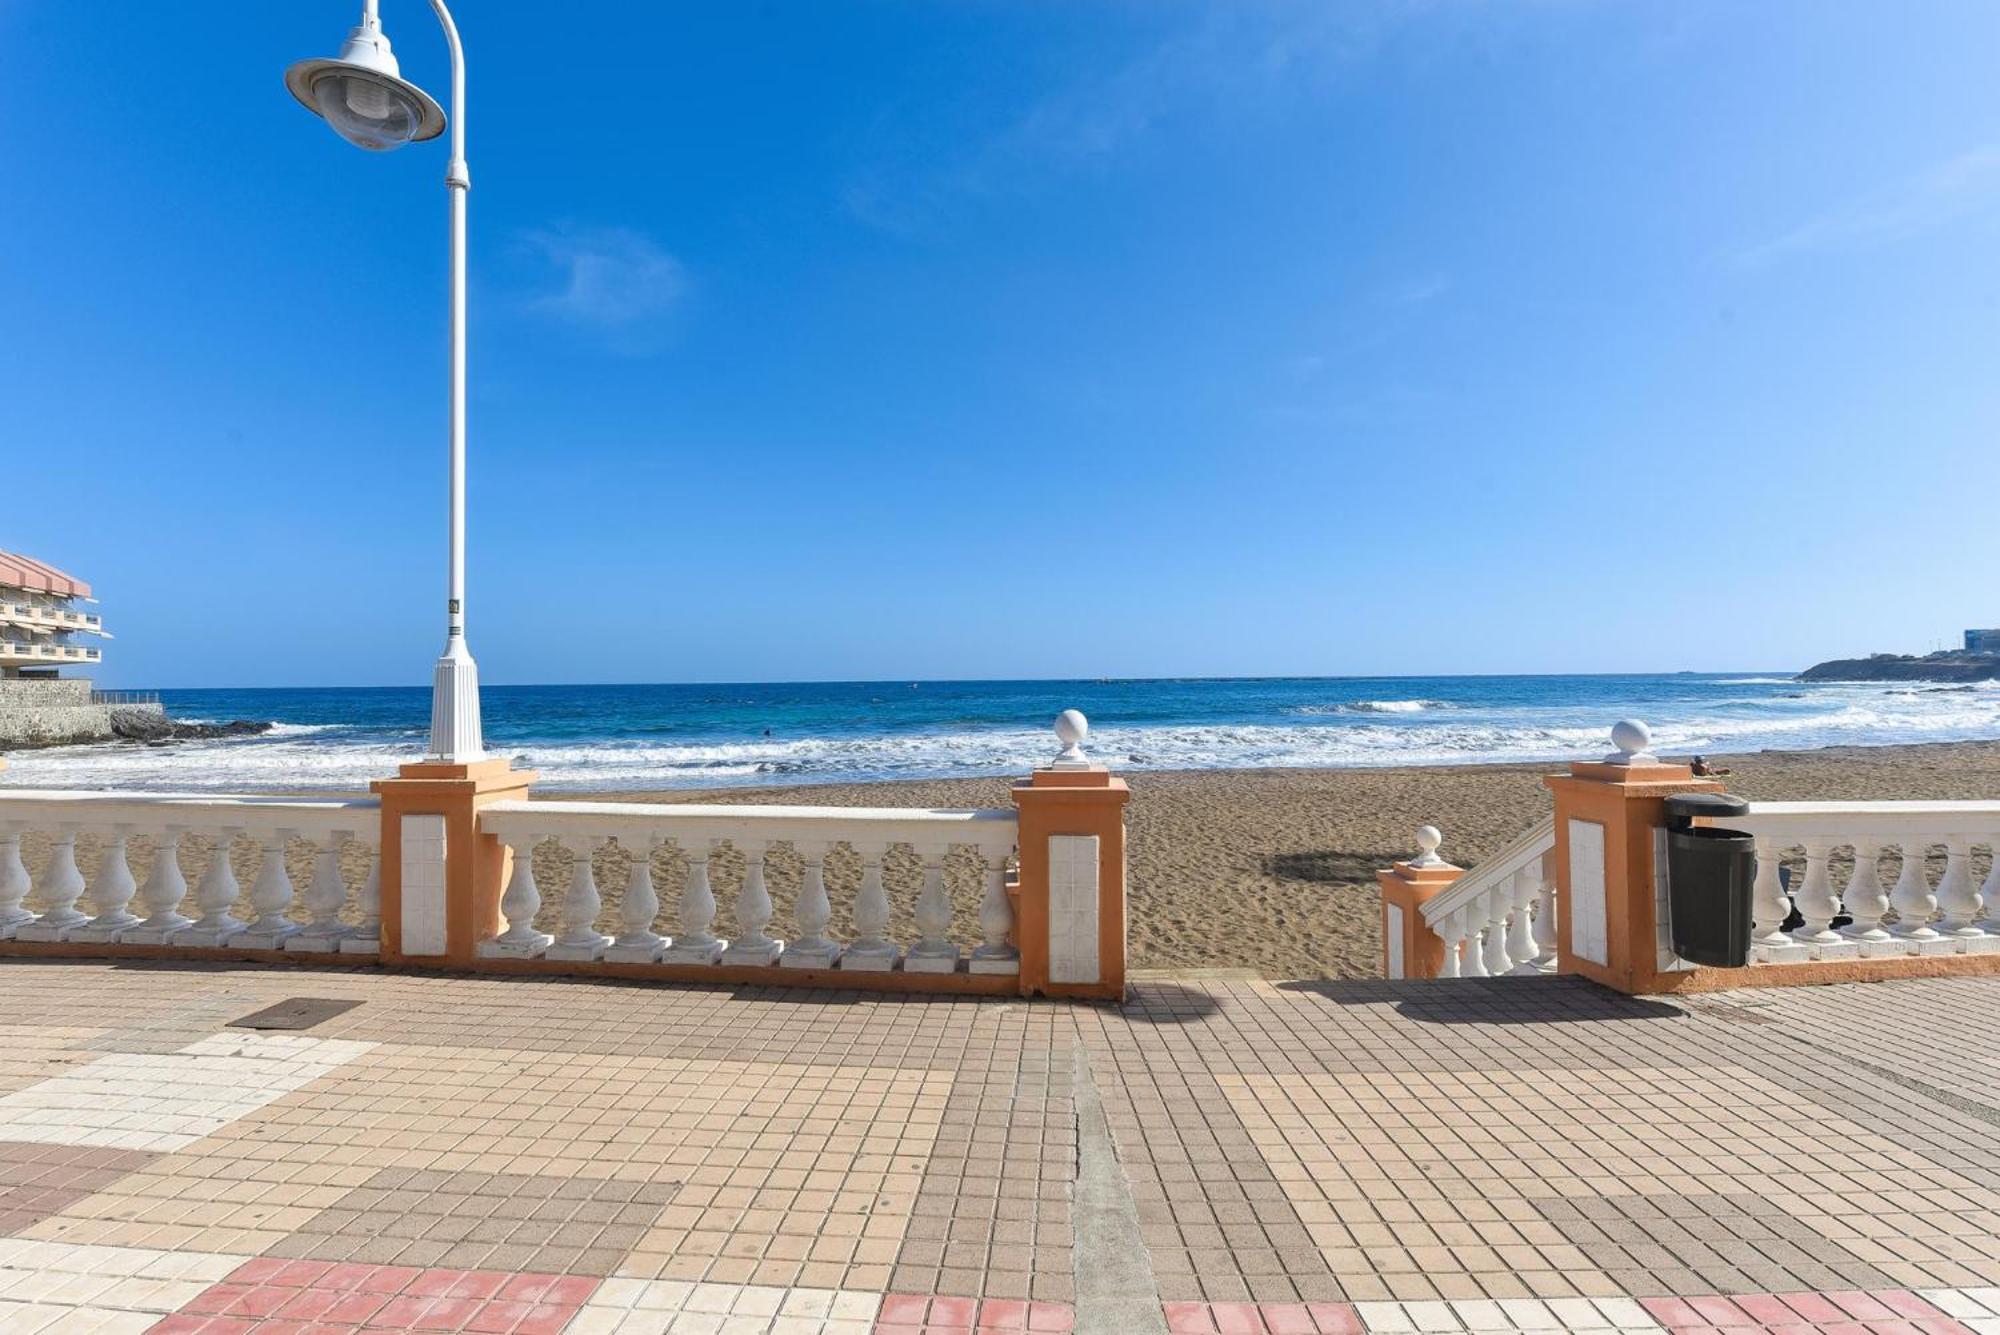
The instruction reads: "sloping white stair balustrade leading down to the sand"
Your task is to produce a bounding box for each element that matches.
[1408,819,1556,977]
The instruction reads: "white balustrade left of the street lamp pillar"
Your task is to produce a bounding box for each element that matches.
[0,789,380,953]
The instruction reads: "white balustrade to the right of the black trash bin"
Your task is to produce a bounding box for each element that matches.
[1700,801,2000,963]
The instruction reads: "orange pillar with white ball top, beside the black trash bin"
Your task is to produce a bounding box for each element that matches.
[1542,723,1722,995]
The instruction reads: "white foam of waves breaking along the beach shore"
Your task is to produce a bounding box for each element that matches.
[15,683,2000,791]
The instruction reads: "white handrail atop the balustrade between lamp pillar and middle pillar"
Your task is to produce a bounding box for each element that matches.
[480,801,1018,851]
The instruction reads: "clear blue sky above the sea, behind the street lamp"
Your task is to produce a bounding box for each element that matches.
[0,0,2000,685]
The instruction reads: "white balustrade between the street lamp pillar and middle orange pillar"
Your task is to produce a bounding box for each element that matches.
[480,801,1020,973]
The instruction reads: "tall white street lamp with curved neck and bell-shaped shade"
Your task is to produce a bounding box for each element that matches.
[284,0,486,761]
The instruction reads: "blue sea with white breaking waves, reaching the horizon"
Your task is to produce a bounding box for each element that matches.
[0,671,2000,791]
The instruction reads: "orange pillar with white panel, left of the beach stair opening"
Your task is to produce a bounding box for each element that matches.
[1014,739,1132,1001]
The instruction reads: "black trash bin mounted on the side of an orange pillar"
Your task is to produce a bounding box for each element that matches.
[1666,793,1756,969]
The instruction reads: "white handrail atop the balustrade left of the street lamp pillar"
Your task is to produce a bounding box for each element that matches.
[0,787,380,843]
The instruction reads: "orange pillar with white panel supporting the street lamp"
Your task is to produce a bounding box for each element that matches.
[370,759,536,967]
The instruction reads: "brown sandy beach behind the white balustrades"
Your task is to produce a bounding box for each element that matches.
[24,741,2000,977]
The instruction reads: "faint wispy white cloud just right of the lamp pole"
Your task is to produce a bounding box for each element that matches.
[520,226,688,344]
